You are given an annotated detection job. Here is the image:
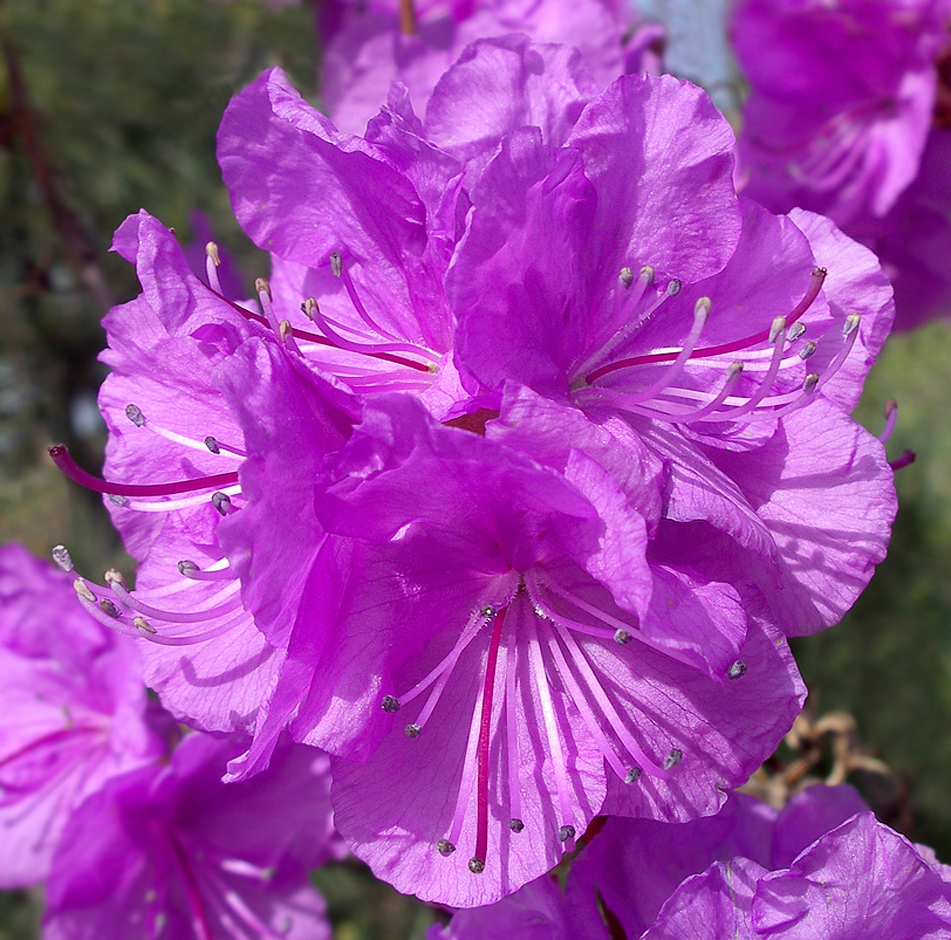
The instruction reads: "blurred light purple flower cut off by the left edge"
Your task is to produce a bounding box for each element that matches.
[0,545,163,888]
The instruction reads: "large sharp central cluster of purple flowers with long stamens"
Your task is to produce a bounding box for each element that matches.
[44,25,894,907]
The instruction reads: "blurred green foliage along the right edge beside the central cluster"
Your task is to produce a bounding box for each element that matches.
[793,322,951,861]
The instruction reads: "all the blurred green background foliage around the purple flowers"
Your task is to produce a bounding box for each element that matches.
[0,0,951,940]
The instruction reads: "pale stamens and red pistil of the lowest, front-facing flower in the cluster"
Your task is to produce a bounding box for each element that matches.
[381,569,720,874]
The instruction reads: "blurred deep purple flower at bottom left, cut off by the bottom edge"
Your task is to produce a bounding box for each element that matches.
[43,734,340,940]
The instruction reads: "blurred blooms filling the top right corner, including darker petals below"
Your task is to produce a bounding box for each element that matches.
[731,0,951,329]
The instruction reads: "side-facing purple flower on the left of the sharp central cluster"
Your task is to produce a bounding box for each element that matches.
[52,213,357,731]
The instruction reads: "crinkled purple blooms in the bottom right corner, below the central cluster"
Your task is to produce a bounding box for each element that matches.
[429,786,951,940]
